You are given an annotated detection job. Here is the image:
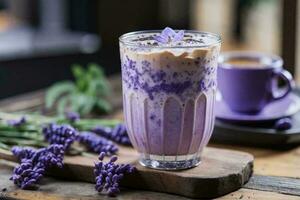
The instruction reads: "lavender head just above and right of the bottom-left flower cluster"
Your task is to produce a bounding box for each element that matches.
[43,124,77,150]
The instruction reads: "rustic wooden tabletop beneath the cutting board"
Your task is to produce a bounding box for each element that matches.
[0,78,300,200]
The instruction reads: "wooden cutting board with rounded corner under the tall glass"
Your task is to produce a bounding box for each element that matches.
[0,147,253,198]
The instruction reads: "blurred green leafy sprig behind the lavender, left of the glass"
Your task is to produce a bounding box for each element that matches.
[46,63,111,115]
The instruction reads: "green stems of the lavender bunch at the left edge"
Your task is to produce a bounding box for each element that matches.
[0,112,121,151]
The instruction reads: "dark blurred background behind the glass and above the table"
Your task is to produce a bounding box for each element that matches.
[0,0,300,98]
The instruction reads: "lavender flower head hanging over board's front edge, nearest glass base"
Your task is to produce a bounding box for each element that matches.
[94,152,136,196]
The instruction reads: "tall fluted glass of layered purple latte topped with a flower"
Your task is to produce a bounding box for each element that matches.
[120,28,220,169]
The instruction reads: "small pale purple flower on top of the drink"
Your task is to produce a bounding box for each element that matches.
[154,27,184,44]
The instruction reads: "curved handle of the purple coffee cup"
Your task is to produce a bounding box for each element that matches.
[271,69,295,101]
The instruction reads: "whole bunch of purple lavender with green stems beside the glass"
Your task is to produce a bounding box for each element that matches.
[0,113,135,196]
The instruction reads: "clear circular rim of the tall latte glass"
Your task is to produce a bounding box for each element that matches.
[119,29,221,49]
